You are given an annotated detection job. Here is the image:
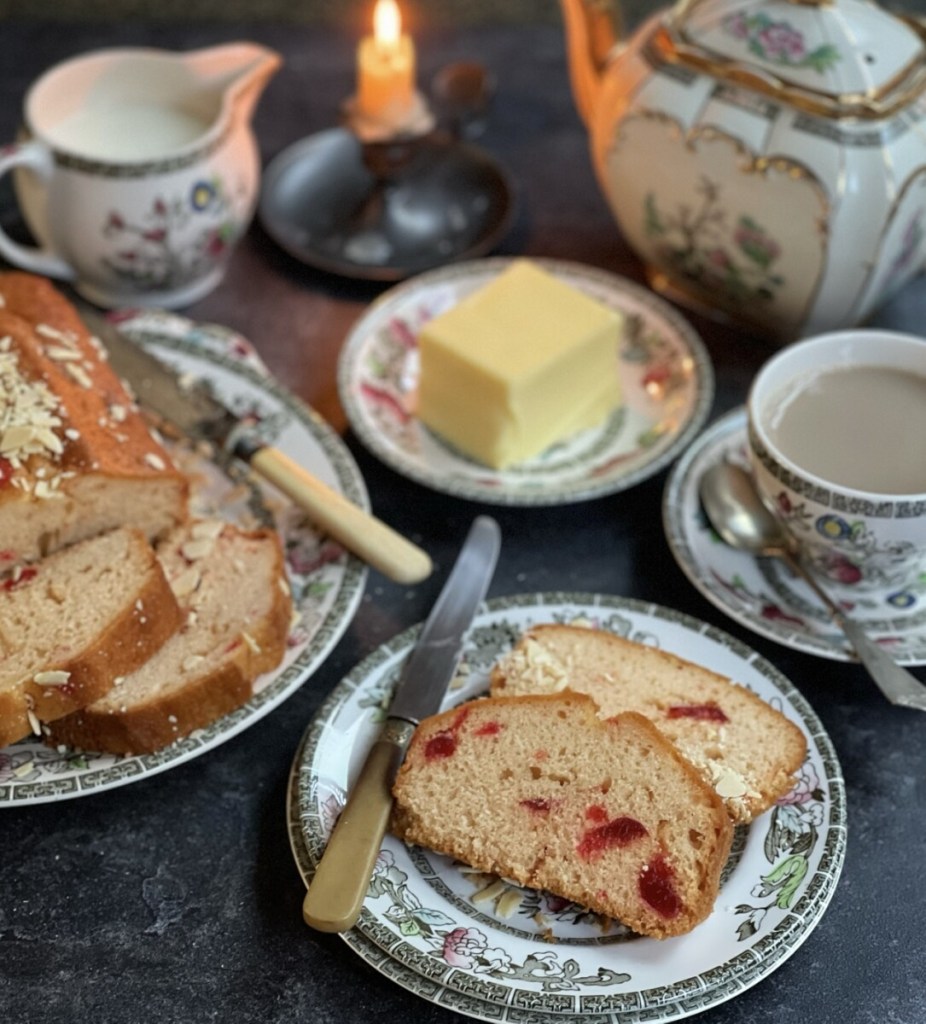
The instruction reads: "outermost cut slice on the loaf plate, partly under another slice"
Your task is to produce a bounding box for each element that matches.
[46,519,292,755]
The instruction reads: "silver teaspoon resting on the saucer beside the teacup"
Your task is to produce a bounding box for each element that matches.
[699,462,926,711]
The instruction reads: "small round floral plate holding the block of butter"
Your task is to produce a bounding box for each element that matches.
[338,257,714,505]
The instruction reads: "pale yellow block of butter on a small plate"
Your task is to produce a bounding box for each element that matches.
[418,259,622,469]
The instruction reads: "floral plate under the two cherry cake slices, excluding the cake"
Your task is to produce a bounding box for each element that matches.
[288,594,846,1024]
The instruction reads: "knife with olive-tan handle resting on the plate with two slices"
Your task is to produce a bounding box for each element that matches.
[302,516,501,932]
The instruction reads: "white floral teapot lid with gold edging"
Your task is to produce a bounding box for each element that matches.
[664,0,926,116]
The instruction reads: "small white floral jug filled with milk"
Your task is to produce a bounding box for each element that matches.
[0,42,281,308]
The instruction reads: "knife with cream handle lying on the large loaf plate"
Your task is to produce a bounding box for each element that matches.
[81,308,431,584]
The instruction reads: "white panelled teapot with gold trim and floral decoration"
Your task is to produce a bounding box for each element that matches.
[561,0,926,344]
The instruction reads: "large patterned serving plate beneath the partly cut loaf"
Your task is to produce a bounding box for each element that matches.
[0,313,369,807]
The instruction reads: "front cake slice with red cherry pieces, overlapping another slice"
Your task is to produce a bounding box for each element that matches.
[391,692,733,938]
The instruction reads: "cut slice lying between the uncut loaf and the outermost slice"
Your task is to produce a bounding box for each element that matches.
[0,529,181,748]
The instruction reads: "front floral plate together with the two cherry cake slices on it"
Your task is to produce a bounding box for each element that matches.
[289,593,846,1024]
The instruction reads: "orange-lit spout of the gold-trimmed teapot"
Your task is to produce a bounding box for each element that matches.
[560,0,623,126]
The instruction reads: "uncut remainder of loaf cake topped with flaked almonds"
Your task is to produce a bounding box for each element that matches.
[0,272,188,572]
